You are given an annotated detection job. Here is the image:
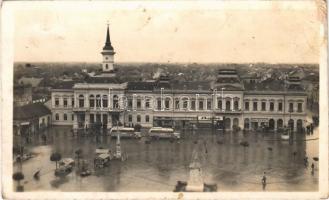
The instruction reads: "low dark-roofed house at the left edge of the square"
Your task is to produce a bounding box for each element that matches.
[13,103,51,135]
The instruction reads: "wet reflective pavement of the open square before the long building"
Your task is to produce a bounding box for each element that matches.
[14,127,319,192]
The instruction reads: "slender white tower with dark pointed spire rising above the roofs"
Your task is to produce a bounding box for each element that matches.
[101,25,115,72]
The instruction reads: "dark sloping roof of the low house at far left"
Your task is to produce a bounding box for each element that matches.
[14,103,51,120]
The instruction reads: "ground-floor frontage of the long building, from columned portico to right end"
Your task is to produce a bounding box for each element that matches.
[68,111,312,132]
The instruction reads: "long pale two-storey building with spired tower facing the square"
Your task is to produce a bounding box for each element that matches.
[51,28,307,133]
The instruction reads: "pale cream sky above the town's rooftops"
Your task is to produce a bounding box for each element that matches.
[9,1,320,63]
